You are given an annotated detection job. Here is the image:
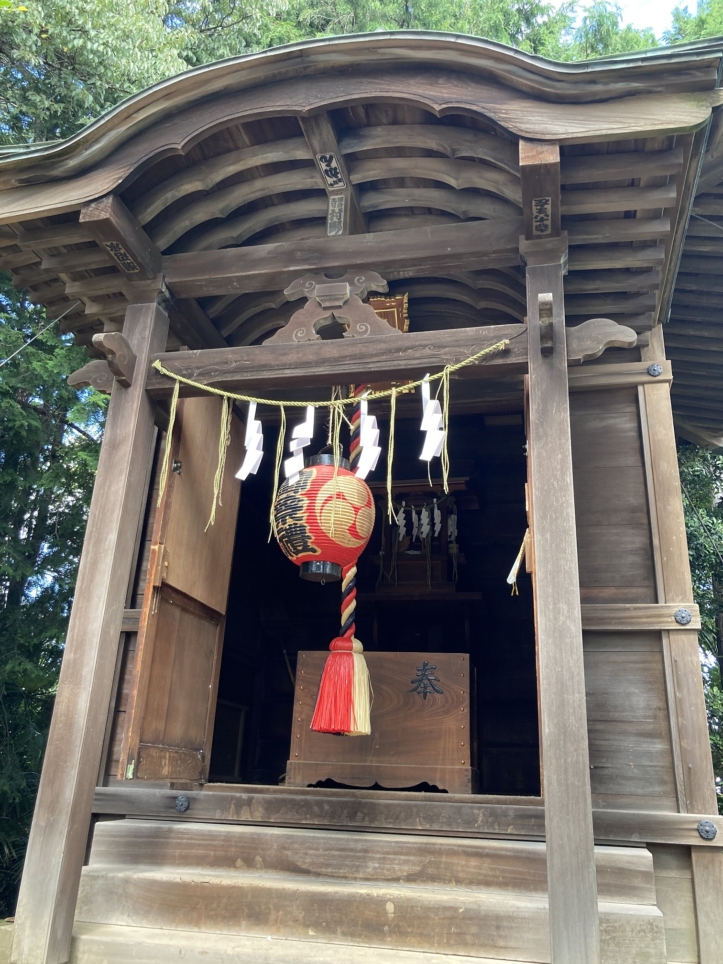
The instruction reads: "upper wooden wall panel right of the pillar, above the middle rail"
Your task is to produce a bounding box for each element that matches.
[570,388,657,603]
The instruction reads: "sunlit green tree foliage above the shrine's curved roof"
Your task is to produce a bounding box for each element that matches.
[0,0,664,144]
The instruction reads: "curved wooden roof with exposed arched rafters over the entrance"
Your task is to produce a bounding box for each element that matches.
[0,32,723,434]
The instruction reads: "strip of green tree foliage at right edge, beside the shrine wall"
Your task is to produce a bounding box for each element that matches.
[678,445,723,813]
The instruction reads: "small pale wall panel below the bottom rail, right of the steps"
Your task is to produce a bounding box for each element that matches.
[648,844,699,964]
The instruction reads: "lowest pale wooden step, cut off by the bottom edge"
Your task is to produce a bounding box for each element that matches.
[69,924,524,964]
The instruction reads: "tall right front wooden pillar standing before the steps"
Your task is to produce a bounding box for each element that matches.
[522,236,600,964]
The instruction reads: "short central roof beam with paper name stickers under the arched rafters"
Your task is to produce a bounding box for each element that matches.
[299,113,367,237]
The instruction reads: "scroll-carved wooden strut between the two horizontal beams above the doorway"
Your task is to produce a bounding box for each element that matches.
[267,271,401,344]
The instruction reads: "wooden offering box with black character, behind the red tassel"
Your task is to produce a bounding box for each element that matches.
[286,651,475,793]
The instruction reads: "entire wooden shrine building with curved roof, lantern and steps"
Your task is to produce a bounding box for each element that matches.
[0,31,723,964]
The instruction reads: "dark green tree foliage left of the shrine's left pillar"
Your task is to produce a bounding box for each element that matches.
[0,274,104,917]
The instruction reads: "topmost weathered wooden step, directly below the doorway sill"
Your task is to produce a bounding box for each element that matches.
[90,819,656,905]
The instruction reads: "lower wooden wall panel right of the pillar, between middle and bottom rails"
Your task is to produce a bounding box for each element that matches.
[584,633,677,810]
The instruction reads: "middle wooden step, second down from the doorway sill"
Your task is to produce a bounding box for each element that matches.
[76,864,665,964]
